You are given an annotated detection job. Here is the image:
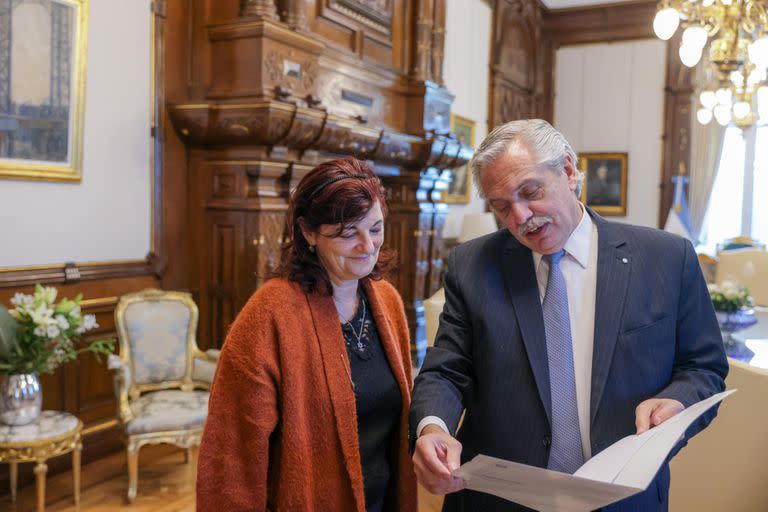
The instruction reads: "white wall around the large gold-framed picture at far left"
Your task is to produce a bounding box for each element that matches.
[0,0,151,267]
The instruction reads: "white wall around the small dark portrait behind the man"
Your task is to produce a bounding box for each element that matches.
[555,39,666,227]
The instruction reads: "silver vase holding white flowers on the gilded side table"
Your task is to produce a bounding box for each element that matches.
[0,373,43,426]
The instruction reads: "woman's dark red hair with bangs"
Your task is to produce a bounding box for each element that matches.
[276,158,395,295]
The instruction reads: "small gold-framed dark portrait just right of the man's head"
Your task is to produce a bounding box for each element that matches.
[579,153,627,216]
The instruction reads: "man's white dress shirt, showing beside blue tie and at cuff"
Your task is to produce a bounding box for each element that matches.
[416,206,597,460]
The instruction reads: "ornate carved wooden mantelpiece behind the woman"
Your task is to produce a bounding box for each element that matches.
[164,0,472,361]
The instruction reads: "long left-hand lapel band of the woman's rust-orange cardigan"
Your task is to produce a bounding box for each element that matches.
[307,294,365,510]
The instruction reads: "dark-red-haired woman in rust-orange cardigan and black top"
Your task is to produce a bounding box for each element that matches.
[197,159,416,512]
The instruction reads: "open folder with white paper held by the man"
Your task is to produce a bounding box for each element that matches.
[453,389,736,512]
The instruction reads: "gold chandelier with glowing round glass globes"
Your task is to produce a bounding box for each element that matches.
[653,0,768,129]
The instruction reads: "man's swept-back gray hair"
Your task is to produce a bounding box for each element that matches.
[469,119,584,198]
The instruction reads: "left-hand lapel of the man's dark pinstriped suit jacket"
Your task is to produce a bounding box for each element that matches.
[501,236,552,422]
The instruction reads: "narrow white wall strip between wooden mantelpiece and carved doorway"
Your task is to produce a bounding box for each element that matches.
[443,0,492,238]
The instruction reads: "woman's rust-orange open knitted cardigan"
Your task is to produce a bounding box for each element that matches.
[197,278,417,512]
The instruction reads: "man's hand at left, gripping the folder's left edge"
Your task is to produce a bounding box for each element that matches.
[413,425,467,494]
